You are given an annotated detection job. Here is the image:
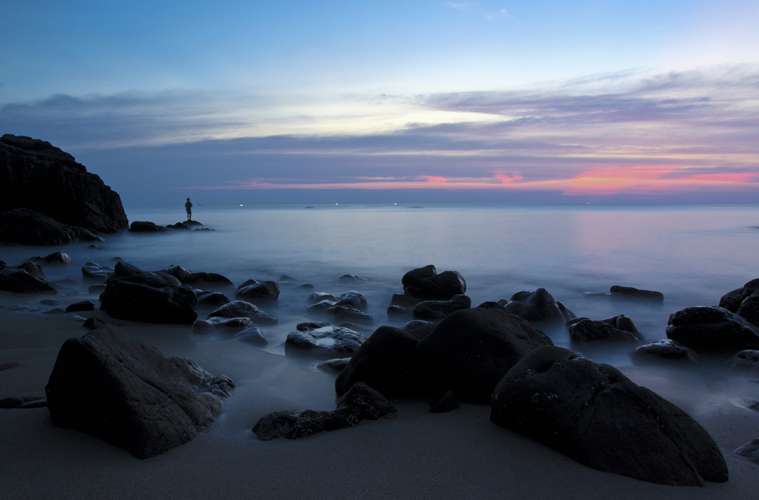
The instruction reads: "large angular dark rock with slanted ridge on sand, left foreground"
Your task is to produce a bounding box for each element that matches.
[45,325,230,458]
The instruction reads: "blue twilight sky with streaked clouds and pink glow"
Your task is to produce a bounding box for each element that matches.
[0,0,759,206]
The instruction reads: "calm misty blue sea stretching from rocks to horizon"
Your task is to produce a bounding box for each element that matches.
[0,205,759,364]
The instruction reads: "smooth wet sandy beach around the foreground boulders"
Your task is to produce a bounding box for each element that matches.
[0,309,759,499]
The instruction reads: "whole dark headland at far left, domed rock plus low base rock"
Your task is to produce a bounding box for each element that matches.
[0,134,128,245]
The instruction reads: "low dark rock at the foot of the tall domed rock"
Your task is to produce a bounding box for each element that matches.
[0,208,103,246]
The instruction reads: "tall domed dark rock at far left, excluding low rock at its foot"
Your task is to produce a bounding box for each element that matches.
[0,134,128,233]
